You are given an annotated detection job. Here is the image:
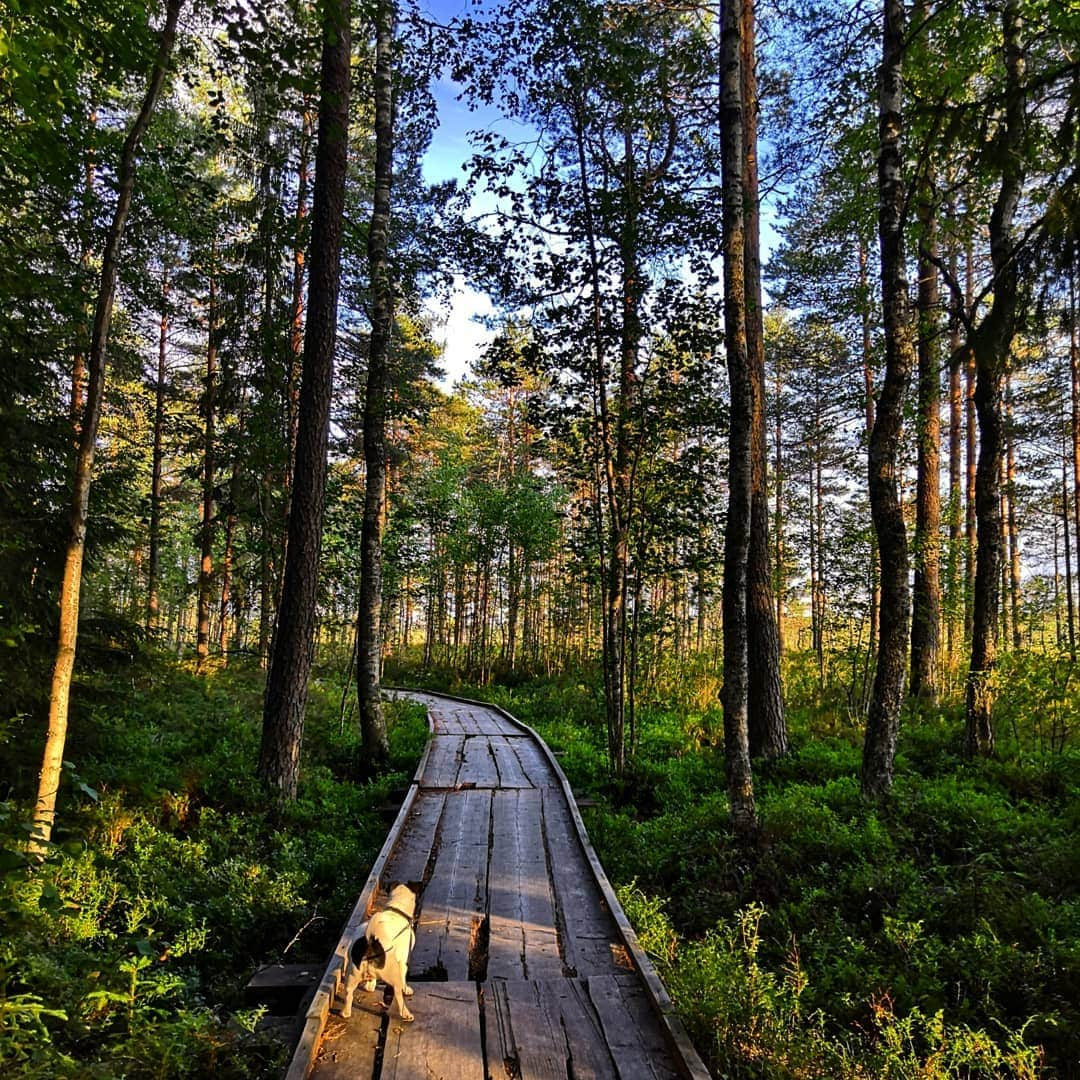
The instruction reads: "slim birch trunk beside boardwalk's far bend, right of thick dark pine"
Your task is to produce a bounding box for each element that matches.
[356,0,394,766]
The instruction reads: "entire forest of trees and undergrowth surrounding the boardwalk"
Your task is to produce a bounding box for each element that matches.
[0,0,1080,1077]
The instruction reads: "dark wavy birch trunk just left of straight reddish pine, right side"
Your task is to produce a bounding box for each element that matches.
[862,0,915,799]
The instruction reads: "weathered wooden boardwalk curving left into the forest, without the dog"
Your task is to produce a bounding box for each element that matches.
[287,692,708,1080]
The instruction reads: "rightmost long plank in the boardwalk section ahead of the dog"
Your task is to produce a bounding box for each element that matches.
[540,788,621,975]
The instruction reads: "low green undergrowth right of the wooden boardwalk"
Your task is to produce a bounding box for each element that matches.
[399,657,1080,1080]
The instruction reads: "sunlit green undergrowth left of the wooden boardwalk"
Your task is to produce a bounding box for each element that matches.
[0,658,427,1078]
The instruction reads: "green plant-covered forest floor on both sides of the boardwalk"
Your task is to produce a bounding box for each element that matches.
[0,643,1080,1080]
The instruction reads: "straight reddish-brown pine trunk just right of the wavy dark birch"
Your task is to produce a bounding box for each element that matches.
[910,194,941,702]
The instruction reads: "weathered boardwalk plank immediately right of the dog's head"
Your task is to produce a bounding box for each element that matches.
[409,789,491,982]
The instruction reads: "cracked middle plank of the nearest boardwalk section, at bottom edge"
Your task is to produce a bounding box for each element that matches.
[484,980,567,1080]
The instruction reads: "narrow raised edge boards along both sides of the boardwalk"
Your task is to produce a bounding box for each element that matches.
[285,687,711,1080]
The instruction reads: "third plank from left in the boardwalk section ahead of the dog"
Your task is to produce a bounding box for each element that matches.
[487,789,563,978]
